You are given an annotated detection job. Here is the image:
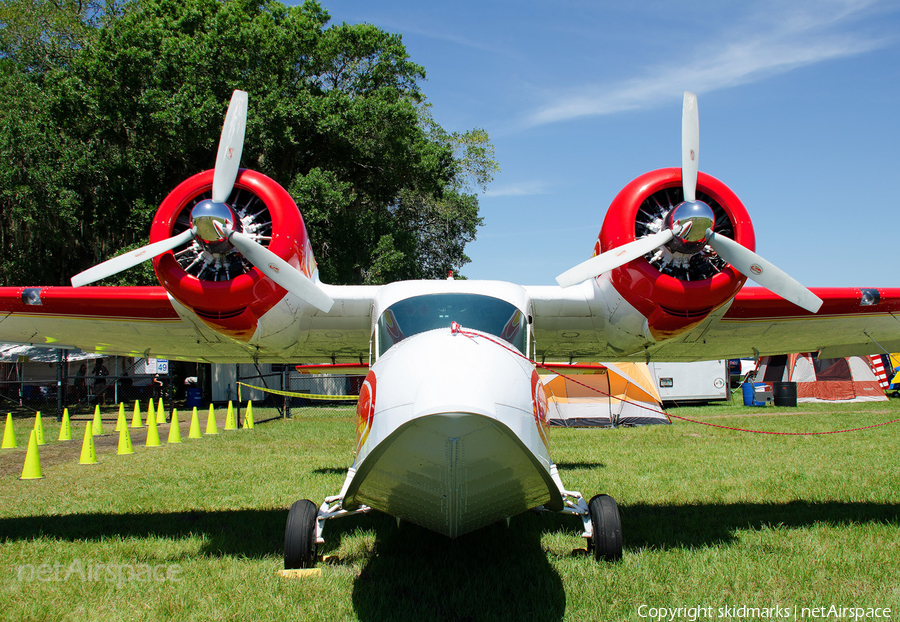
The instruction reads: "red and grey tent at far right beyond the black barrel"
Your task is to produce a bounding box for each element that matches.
[756,353,887,403]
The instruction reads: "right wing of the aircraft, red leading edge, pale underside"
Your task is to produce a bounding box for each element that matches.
[526,288,900,362]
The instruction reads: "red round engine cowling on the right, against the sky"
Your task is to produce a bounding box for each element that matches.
[594,168,756,339]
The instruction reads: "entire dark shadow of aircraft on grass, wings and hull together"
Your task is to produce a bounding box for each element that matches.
[0,501,900,620]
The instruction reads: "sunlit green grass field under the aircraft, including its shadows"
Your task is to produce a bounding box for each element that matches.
[0,400,900,621]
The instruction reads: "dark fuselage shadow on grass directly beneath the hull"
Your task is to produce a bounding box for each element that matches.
[326,514,568,621]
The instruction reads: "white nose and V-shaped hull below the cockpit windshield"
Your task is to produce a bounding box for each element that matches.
[343,328,562,537]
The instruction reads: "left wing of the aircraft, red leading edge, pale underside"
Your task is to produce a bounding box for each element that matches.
[0,287,377,363]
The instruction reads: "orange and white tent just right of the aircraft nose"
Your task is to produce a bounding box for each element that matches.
[543,363,671,427]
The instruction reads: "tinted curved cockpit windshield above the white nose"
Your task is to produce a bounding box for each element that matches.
[378,293,528,356]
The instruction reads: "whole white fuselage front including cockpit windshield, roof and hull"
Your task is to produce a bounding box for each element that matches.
[334,282,563,537]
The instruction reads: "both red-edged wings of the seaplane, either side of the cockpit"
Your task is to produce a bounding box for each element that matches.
[0,281,900,364]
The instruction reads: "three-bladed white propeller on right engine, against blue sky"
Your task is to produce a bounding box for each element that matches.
[556,91,822,313]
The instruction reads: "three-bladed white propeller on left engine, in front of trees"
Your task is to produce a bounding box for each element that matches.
[72,90,334,313]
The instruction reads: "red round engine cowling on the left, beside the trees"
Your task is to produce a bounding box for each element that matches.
[150,169,316,341]
